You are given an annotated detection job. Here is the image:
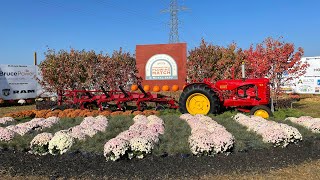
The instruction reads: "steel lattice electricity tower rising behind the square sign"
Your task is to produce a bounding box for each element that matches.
[162,0,187,43]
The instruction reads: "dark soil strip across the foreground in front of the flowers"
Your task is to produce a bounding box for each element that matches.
[0,139,320,179]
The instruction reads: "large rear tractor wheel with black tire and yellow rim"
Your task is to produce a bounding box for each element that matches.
[179,84,220,115]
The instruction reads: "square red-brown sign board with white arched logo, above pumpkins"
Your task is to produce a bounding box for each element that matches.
[136,43,187,90]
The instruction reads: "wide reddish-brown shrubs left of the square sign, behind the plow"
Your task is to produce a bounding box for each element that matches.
[39,48,140,92]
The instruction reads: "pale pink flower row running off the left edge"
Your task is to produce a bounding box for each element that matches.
[0,117,59,141]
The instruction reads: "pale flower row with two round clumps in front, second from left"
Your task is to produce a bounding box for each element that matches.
[30,116,108,155]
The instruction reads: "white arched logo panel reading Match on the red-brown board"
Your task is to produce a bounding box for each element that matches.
[145,54,178,80]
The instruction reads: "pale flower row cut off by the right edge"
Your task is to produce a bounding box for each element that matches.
[285,116,320,133]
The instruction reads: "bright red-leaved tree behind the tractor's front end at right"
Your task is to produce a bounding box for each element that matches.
[244,37,308,92]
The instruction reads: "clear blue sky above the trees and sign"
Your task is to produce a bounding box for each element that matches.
[0,0,320,64]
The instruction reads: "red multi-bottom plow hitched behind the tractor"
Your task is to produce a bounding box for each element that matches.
[57,85,178,111]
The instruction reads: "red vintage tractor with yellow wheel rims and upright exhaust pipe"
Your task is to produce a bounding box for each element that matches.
[179,66,272,119]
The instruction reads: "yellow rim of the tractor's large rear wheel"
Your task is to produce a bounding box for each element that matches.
[186,93,210,115]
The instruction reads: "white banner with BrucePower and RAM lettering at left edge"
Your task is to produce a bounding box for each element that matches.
[0,64,43,100]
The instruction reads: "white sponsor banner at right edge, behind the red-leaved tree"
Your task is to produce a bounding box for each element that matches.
[283,56,320,94]
